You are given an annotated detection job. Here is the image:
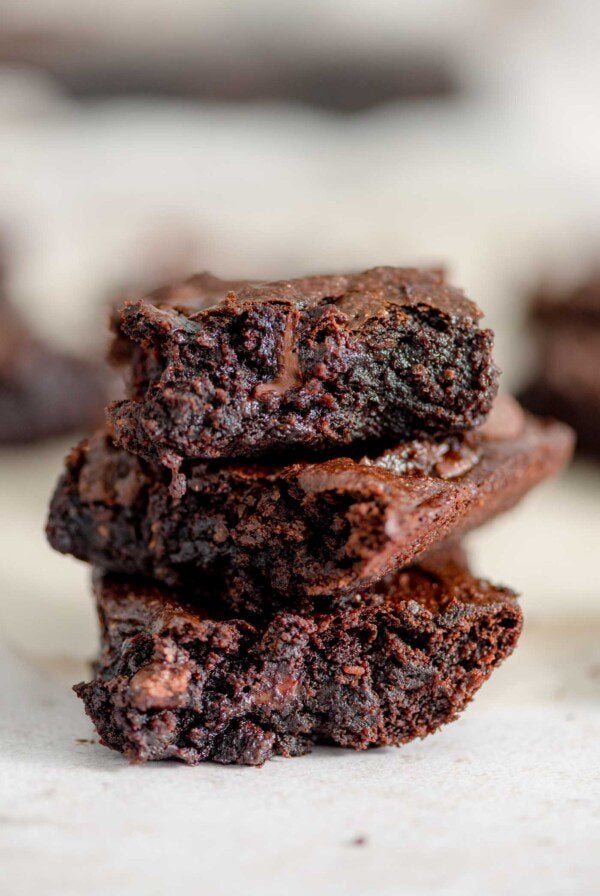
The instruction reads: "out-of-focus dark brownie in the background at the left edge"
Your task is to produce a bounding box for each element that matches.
[0,297,105,444]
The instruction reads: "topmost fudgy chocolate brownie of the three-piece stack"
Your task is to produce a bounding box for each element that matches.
[109,267,497,469]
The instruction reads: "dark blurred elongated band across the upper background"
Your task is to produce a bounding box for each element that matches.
[0,31,459,112]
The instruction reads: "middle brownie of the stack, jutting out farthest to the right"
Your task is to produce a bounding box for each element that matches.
[47,398,572,612]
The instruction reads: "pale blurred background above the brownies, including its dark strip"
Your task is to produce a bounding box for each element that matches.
[0,0,600,374]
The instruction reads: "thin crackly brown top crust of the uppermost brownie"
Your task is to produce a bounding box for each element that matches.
[115,267,481,342]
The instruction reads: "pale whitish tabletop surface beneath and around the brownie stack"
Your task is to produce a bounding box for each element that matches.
[0,444,600,896]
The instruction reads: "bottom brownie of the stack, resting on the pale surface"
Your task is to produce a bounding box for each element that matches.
[75,561,521,765]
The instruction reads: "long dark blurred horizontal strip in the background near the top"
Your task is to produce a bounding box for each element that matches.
[0,24,463,112]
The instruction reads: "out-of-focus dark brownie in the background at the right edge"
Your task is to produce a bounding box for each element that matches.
[521,271,600,456]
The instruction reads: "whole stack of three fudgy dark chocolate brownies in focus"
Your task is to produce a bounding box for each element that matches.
[47,268,573,765]
